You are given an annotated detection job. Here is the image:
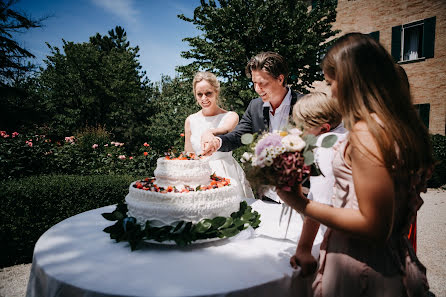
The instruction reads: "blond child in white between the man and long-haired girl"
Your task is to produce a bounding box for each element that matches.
[290,92,347,277]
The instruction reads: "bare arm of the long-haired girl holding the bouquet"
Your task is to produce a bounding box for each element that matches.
[279,123,395,242]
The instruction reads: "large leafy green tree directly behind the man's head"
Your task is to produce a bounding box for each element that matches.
[178,0,337,112]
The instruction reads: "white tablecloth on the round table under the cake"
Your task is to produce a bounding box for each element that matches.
[26,199,322,297]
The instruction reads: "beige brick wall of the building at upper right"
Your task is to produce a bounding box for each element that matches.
[314,0,446,135]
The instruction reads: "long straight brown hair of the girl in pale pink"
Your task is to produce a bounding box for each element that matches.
[322,33,433,186]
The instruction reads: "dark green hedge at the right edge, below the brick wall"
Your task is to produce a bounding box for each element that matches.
[427,134,446,188]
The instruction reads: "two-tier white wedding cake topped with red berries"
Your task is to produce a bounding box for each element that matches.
[125,157,240,226]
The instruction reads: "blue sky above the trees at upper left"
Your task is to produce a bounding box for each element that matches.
[12,0,200,82]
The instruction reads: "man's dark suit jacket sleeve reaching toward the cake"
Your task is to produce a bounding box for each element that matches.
[218,101,255,152]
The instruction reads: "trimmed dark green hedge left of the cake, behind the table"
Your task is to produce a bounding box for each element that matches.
[0,175,140,267]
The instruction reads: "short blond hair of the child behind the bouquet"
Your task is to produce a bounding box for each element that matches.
[293,92,342,128]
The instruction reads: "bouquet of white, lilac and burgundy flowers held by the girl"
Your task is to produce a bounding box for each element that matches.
[240,128,337,194]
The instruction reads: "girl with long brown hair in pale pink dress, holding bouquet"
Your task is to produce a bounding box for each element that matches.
[279,33,433,296]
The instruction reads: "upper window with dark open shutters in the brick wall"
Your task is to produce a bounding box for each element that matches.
[392,17,436,62]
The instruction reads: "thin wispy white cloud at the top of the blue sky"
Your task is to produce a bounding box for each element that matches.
[91,0,139,26]
